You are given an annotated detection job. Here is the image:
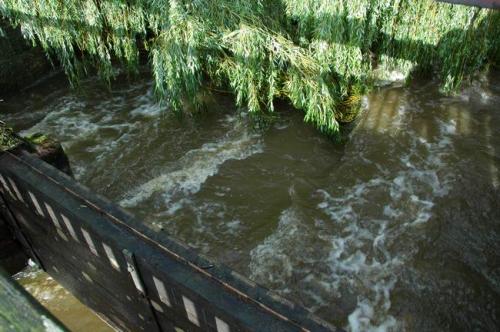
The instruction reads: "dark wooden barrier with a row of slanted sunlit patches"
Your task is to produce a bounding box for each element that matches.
[0,151,336,332]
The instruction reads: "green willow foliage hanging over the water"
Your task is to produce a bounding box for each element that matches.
[0,0,500,134]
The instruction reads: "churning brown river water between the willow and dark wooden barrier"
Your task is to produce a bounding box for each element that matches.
[0,72,500,331]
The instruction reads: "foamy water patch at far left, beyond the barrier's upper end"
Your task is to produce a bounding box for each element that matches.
[21,83,163,179]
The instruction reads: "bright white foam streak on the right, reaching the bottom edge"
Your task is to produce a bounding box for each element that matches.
[318,121,456,332]
